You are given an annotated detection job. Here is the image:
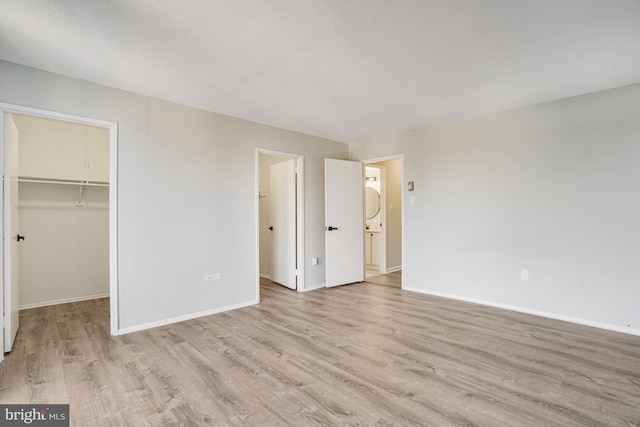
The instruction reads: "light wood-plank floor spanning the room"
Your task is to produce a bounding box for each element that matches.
[0,281,640,427]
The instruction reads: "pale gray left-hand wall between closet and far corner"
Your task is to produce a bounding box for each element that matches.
[0,61,348,331]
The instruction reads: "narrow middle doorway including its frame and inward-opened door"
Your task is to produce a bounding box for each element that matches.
[256,149,305,299]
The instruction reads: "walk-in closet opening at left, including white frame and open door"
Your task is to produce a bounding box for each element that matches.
[2,108,117,358]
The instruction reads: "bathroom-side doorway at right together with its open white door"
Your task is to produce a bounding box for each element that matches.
[325,155,404,288]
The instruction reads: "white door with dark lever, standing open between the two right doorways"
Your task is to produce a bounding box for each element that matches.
[324,159,364,286]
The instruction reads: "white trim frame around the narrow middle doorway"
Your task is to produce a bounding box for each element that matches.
[254,148,305,302]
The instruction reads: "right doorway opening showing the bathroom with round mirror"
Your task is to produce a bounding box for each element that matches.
[364,156,403,284]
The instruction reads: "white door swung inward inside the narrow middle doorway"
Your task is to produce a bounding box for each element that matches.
[269,159,297,289]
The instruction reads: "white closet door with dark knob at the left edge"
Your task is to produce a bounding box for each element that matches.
[2,114,21,352]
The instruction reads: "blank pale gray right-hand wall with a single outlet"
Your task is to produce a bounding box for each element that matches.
[350,85,640,334]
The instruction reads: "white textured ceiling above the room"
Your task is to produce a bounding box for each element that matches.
[0,0,640,142]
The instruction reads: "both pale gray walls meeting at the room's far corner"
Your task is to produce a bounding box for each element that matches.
[0,57,640,334]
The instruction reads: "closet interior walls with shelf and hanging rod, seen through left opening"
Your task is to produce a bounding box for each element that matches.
[12,114,110,309]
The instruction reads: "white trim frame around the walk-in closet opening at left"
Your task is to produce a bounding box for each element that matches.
[0,102,119,360]
